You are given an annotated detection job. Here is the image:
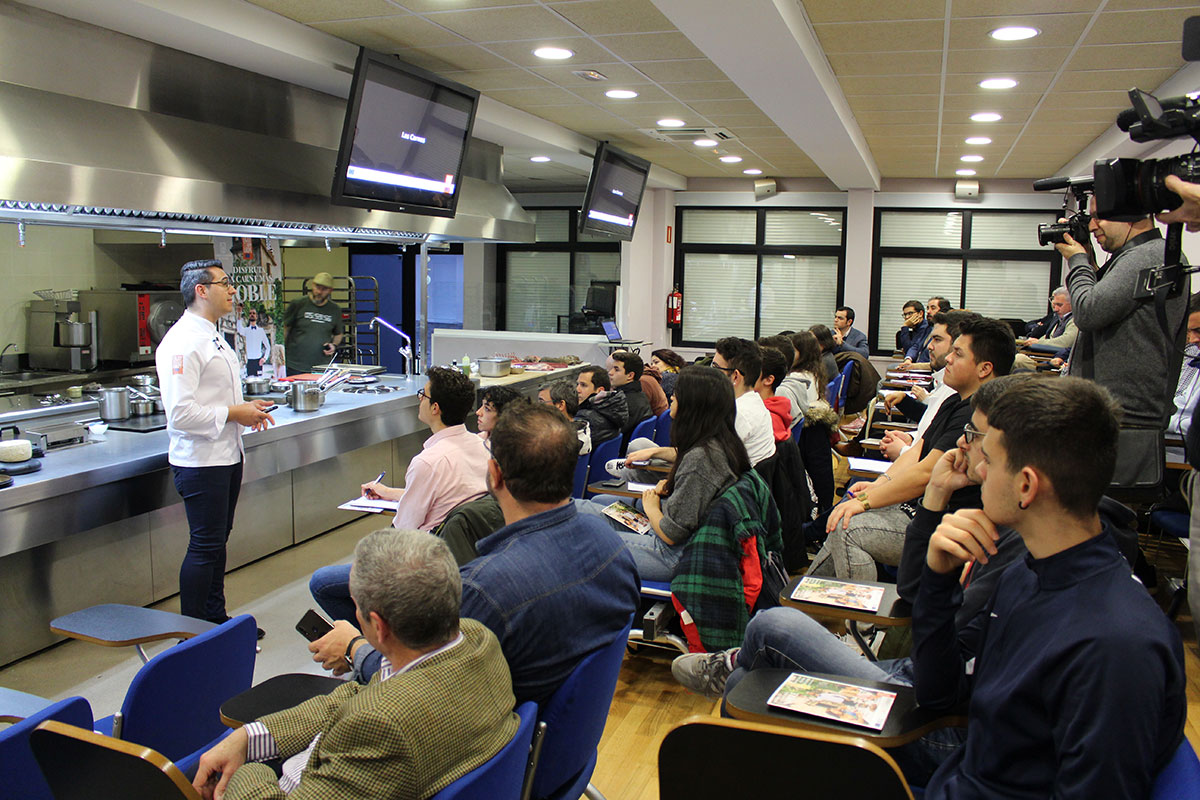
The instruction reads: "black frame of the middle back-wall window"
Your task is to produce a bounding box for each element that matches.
[671,205,848,349]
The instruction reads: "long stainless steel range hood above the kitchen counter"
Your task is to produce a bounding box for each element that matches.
[0,1,533,243]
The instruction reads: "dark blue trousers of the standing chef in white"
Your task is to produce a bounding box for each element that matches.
[172,462,241,622]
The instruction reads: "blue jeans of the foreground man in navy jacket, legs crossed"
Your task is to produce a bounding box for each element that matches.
[725,608,966,786]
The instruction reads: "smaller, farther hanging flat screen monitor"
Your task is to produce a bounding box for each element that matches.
[580,142,650,241]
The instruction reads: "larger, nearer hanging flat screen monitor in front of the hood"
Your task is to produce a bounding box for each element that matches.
[332,48,479,217]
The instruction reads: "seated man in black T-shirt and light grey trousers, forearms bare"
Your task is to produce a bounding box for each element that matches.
[809,317,1016,581]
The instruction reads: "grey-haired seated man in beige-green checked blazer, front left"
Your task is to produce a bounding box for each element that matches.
[194,529,517,800]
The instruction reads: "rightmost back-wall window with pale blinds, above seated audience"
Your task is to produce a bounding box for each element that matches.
[871,209,1062,353]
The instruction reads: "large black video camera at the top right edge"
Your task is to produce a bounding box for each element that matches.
[1092,89,1200,222]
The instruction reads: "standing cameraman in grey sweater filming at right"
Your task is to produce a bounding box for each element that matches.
[1055,199,1189,431]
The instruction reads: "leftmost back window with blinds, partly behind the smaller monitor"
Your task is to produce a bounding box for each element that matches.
[497,209,620,333]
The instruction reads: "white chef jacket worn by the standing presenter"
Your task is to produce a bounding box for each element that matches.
[155,311,244,467]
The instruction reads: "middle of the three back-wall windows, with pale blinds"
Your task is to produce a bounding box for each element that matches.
[673,209,845,347]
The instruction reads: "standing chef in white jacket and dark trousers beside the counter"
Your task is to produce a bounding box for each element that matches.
[155,260,275,634]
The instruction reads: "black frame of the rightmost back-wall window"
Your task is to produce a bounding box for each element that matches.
[868,206,1063,355]
